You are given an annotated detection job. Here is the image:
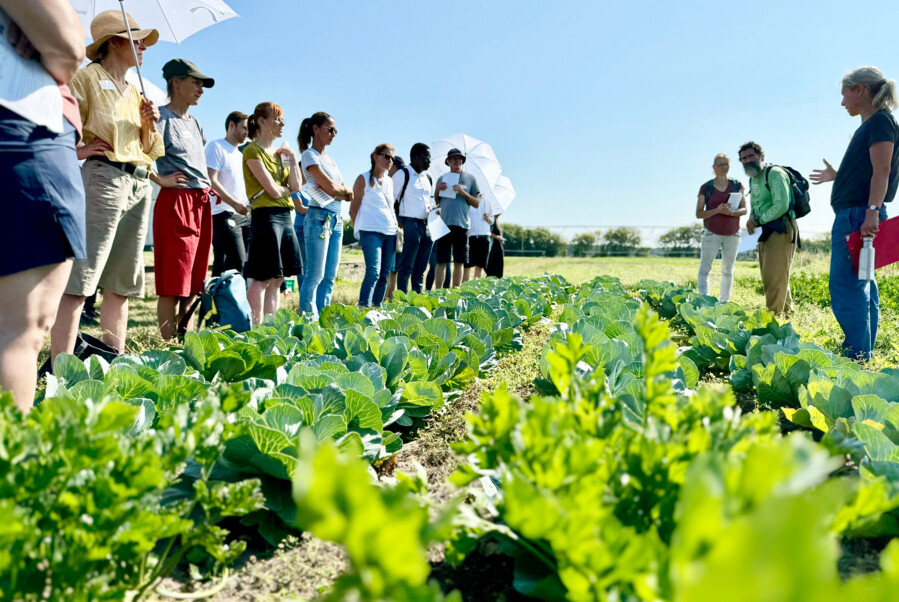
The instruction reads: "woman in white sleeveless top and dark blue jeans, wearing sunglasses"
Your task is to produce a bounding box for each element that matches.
[350,144,398,307]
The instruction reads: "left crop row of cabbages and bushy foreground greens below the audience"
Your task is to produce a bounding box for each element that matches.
[0,278,569,600]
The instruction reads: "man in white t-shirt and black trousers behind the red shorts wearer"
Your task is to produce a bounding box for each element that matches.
[206,111,249,276]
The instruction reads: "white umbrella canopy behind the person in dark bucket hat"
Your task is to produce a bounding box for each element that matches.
[429,134,515,215]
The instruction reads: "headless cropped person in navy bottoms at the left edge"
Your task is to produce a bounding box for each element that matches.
[0,0,85,412]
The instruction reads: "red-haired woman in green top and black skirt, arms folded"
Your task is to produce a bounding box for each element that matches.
[243,102,306,324]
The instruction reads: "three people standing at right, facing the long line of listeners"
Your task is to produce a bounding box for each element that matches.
[696,67,899,359]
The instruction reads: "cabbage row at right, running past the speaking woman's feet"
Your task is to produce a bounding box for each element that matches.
[643,284,899,536]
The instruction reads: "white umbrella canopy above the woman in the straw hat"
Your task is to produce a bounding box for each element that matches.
[69,0,237,44]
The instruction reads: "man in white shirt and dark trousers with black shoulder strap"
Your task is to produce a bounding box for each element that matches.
[393,142,434,293]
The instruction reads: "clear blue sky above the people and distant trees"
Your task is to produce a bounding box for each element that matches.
[126,0,899,241]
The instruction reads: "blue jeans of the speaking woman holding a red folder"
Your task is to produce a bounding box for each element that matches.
[830,207,887,359]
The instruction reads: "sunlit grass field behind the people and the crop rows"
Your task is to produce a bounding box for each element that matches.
[67,249,899,369]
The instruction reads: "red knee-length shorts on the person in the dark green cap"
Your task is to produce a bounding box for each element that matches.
[153,188,212,297]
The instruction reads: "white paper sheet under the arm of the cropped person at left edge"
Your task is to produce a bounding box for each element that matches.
[0,11,63,134]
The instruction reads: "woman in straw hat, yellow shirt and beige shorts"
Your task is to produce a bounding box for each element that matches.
[51,10,171,358]
